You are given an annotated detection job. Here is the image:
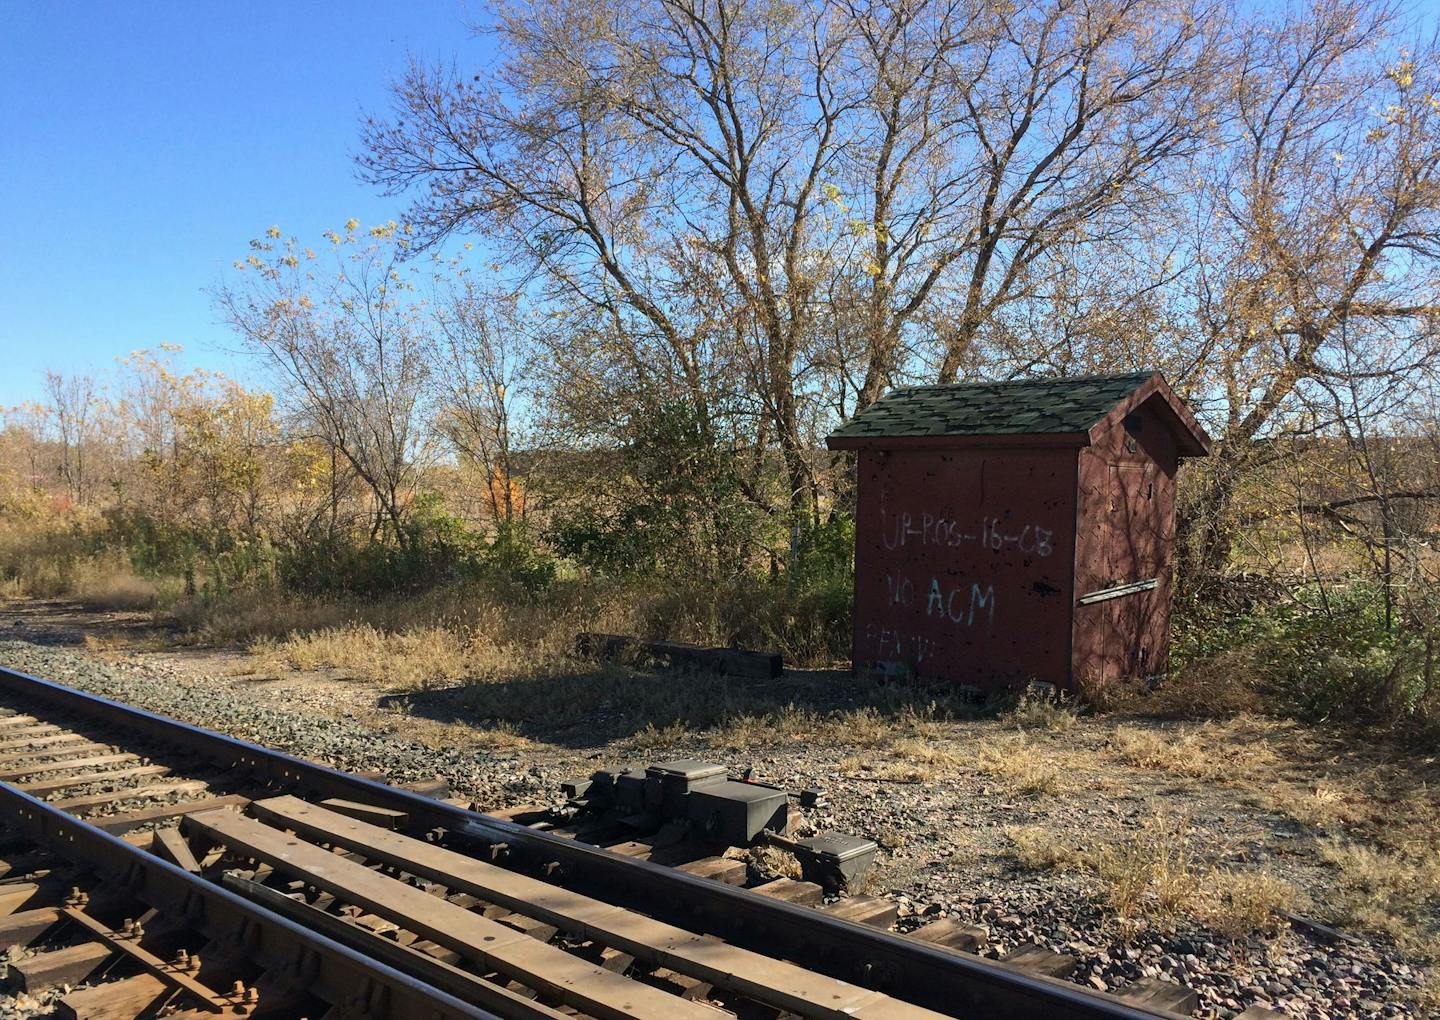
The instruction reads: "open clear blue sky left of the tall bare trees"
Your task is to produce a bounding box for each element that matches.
[0,0,487,406]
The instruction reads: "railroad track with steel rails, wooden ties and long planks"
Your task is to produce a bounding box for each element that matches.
[0,670,1263,1020]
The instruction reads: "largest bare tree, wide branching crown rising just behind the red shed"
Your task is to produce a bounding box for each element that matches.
[361,0,1218,527]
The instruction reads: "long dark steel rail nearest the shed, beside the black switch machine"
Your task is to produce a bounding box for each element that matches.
[0,668,1179,1020]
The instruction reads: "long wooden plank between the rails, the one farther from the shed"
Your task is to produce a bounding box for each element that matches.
[183,798,726,1020]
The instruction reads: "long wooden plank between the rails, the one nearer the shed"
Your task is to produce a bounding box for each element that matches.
[240,797,940,1020]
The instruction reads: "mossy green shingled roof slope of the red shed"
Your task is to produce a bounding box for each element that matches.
[829,372,1155,439]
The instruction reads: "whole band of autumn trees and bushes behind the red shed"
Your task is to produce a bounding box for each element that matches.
[6,0,1440,680]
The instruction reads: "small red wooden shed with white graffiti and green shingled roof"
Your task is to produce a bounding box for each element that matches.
[828,372,1210,690]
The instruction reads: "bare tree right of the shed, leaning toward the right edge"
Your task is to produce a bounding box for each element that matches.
[1181,0,1440,578]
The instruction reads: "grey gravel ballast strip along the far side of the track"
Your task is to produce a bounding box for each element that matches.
[0,641,1440,1020]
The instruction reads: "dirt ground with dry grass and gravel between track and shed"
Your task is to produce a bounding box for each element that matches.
[0,601,1440,1016]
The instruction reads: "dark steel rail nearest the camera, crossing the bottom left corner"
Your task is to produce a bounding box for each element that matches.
[0,784,501,1020]
